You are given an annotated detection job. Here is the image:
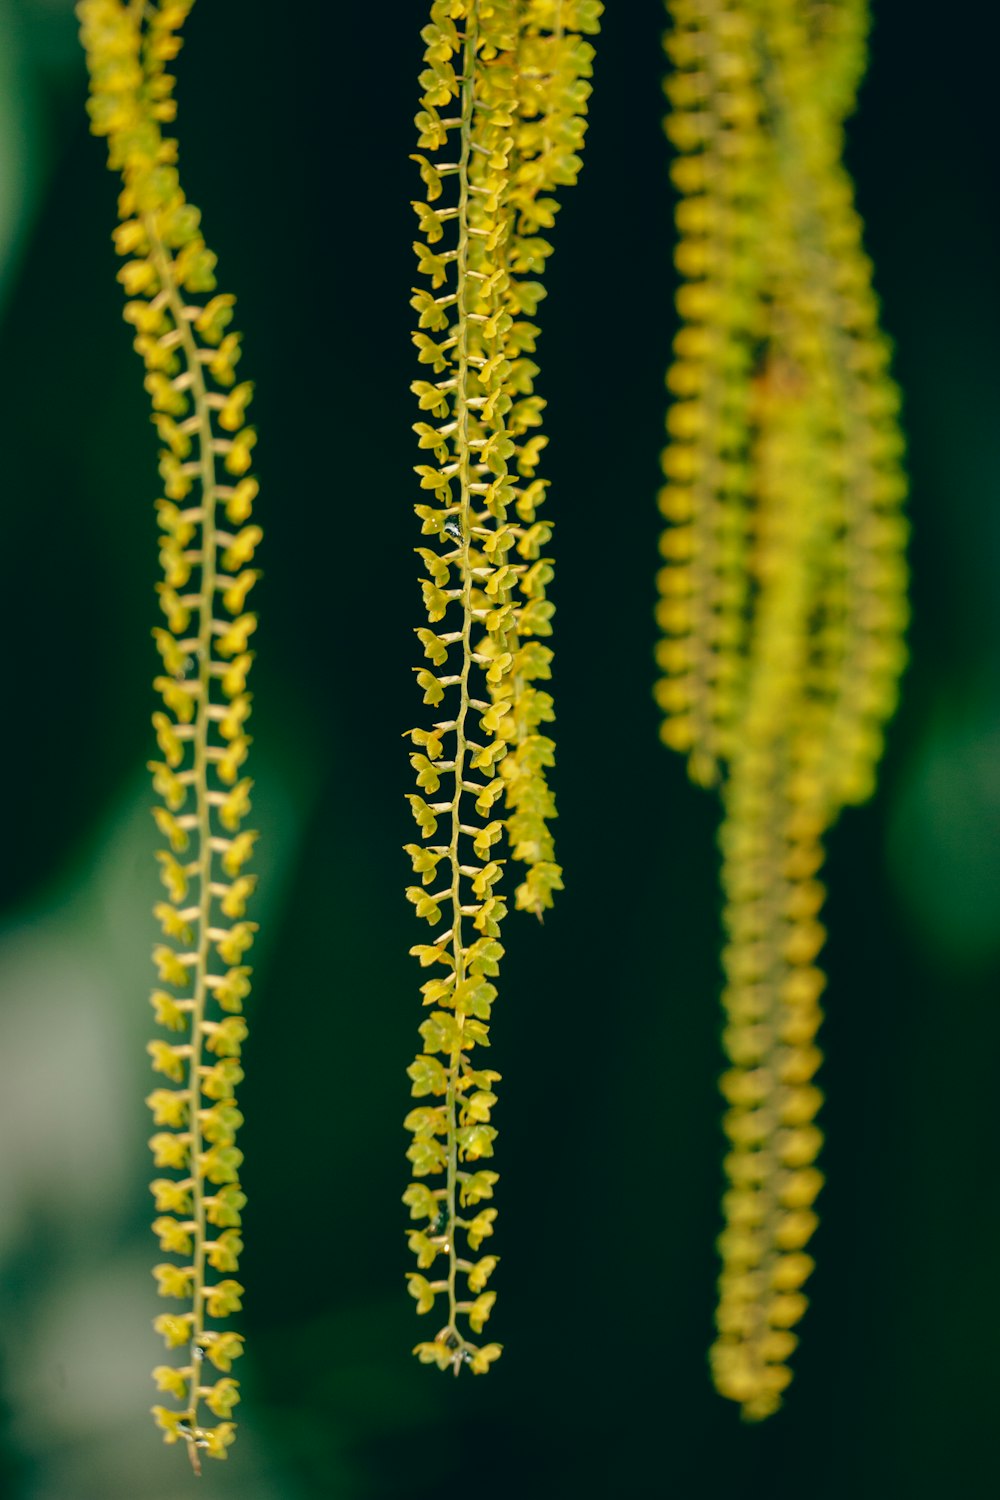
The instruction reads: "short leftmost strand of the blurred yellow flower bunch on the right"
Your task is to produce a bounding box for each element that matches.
[657,0,765,785]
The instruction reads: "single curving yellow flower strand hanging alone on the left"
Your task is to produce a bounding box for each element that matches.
[76,0,261,1470]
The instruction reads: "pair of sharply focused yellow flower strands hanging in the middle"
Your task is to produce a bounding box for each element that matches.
[403,0,600,1374]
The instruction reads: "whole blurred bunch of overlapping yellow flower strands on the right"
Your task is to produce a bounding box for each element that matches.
[658,0,907,1418]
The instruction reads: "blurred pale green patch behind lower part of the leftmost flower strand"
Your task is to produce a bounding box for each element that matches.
[0,756,315,1500]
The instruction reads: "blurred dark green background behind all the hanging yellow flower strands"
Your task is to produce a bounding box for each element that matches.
[0,0,1000,1500]
